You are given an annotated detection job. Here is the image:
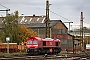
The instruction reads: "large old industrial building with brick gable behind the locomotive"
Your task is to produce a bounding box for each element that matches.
[0,15,73,51]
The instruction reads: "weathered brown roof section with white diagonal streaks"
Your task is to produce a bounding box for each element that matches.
[18,15,46,24]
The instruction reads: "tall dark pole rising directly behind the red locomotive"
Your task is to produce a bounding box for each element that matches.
[46,0,50,38]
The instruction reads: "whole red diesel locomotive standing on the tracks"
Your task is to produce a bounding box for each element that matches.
[26,37,61,54]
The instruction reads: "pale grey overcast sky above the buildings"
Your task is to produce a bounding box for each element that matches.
[0,0,90,28]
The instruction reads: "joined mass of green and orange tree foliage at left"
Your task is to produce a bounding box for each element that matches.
[0,11,37,44]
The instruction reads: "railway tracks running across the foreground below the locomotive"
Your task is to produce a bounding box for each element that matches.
[0,54,90,60]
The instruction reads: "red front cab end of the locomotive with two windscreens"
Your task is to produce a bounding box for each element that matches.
[26,37,39,54]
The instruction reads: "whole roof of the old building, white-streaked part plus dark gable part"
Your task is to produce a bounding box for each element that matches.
[0,15,67,28]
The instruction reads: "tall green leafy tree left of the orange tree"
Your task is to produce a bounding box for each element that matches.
[2,11,18,43]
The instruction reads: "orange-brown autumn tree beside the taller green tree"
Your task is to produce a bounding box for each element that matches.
[18,25,37,42]
